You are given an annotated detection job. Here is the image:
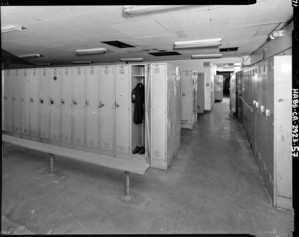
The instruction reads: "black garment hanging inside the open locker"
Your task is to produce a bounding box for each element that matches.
[132,83,144,124]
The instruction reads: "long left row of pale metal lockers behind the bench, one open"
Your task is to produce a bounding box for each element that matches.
[3,63,180,168]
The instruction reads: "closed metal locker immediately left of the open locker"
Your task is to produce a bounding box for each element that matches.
[115,65,133,154]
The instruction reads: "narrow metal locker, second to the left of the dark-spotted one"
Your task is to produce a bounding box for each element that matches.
[28,69,39,138]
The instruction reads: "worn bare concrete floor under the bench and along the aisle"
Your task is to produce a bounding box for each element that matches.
[2,98,293,237]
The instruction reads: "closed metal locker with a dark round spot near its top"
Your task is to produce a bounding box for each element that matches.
[50,68,61,142]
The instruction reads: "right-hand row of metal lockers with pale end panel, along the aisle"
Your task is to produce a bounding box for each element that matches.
[233,56,292,209]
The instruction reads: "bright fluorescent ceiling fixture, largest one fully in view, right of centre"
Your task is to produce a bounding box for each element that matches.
[173,38,222,49]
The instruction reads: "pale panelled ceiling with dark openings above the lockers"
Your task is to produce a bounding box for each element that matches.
[1,0,292,65]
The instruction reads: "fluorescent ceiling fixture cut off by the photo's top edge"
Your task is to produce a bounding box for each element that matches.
[124,5,187,15]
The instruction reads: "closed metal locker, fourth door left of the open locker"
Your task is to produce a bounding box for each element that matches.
[72,67,86,146]
